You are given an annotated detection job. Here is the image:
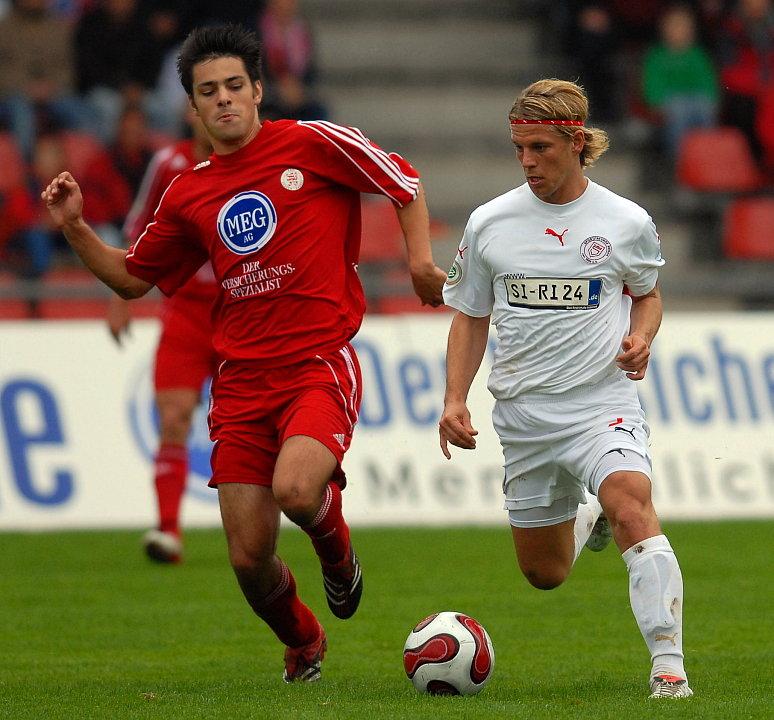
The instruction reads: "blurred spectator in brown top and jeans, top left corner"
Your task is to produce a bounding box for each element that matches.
[0,0,90,158]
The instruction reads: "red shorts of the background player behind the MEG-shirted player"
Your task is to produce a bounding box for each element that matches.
[154,297,218,392]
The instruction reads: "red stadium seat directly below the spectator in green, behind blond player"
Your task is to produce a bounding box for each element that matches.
[676,127,762,193]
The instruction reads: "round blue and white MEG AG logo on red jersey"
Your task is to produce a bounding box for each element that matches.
[218,190,277,255]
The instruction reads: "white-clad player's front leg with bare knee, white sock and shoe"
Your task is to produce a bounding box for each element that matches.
[599,471,691,697]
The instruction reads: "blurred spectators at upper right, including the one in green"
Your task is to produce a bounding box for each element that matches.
[552,0,774,172]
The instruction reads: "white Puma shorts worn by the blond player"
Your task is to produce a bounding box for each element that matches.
[492,377,651,527]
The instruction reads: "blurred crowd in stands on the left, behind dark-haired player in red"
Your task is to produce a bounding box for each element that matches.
[0,0,327,292]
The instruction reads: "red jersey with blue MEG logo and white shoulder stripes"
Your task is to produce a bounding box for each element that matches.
[126,120,419,367]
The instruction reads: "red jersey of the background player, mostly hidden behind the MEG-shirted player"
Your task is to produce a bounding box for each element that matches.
[124,140,217,302]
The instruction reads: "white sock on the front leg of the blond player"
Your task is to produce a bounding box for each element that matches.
[622,535,686,678]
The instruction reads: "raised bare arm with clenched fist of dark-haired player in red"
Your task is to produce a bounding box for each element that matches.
[40,172,153,299]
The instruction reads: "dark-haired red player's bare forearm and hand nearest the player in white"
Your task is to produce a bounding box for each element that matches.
[395,185,446,307]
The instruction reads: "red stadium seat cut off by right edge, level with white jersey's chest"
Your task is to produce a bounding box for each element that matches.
[723,196,774,260]
